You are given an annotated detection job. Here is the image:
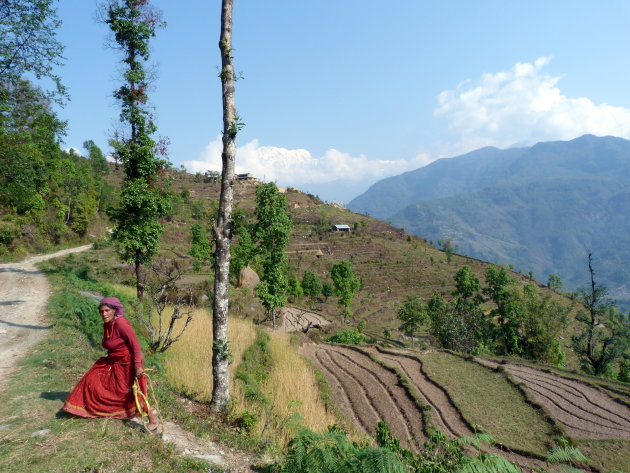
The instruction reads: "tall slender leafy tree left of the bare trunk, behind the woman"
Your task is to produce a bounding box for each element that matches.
[105,0,168,299]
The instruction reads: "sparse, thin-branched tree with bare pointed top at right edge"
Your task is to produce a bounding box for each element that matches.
[573,252,630,376]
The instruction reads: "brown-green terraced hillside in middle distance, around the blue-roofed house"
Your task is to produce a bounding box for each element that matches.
[158,168,584,361]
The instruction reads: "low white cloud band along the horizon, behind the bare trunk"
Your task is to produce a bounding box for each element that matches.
[184,136,430,187]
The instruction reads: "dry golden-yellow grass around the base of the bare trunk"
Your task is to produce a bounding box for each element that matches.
[165,310,338,444]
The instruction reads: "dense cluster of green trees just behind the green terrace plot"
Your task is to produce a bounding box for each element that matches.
[426,266,569,365]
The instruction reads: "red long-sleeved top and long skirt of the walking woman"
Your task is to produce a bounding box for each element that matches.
[63,317,147,419]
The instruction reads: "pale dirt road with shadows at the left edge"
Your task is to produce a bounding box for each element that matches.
[0,245,92,389]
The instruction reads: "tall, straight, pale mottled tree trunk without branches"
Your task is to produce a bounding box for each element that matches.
[212,0,239,411]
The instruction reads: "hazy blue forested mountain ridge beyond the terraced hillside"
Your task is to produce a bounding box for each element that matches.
[349,135,630,308]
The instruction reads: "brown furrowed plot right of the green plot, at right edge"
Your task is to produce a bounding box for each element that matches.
[479,360,630,439]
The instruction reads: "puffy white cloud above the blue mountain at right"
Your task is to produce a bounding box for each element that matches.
[435,57,630,150]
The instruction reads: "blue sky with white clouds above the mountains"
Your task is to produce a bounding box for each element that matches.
[59,0,630,202]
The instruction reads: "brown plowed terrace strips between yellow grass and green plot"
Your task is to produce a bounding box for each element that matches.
[302,344,545,472]
